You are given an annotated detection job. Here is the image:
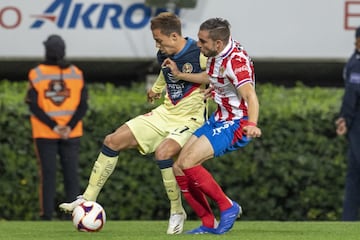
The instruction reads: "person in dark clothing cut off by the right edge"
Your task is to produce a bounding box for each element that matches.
[336,27,360,221]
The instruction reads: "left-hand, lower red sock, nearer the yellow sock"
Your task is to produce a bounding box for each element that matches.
[176,176,215,228]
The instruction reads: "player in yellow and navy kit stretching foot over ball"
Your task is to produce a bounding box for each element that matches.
[59,12,206,234]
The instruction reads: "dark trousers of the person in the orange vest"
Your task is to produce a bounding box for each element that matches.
[35,138,80,220]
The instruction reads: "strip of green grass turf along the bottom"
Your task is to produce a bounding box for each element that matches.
[0,221,360,240]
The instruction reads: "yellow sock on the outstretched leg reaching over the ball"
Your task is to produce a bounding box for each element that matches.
[83,153,118,201]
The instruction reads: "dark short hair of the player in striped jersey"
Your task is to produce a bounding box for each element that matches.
[200,18,230,43]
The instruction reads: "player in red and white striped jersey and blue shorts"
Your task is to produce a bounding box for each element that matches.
[163,18,261,234]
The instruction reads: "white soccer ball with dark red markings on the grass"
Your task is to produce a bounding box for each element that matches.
[72,201,106,232]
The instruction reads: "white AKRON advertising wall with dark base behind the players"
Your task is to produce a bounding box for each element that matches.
[0,0,360,86]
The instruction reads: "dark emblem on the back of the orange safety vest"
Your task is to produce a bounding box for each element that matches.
[45,80,70,106]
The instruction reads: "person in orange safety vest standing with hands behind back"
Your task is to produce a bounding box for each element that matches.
[26,35,88,220]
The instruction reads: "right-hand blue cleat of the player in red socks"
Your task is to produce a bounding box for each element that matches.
[216,201,242,234]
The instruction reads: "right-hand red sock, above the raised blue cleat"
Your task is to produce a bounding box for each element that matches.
[183,165,232,211]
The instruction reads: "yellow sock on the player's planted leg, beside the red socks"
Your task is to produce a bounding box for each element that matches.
[161,168,185,214]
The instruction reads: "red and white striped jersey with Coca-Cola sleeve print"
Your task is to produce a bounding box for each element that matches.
[206,39,255,121]
